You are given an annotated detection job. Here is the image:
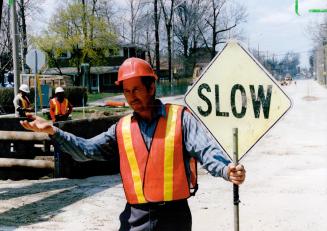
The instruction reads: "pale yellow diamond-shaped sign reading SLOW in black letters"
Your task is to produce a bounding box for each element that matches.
[184,41,291,159]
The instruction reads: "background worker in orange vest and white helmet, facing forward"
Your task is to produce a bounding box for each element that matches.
[50,87,73,122]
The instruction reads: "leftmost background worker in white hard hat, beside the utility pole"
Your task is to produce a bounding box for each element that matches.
[13,84,33,117]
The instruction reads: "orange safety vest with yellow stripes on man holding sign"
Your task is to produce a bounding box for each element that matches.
[116,104,197,204]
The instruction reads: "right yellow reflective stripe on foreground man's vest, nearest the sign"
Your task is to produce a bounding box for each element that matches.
[164,105,178,201]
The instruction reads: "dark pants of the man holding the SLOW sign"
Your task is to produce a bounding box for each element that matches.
[119,200,192,231]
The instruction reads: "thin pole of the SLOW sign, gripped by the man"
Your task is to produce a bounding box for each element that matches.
[233,128,240,231]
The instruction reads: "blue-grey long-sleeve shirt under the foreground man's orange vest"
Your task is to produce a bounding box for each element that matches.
[52,100,230,180]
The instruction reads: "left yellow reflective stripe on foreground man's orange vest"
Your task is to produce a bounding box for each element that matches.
[122,115,146,203]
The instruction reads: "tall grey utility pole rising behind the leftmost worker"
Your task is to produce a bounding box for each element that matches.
[10,0,20,95]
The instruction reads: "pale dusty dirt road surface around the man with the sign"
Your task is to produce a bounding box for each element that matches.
[0,80,327,231]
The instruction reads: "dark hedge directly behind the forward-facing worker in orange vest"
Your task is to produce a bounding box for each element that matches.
[52,87,87,107]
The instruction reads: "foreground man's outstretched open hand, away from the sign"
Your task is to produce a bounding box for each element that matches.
[20,114,55,135]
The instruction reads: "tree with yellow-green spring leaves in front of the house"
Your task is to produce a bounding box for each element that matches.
[34,0,117,75]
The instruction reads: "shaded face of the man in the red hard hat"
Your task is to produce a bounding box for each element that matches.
[123,78,155,113]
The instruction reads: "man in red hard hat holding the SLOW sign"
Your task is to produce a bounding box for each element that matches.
[21,58,245,231]
